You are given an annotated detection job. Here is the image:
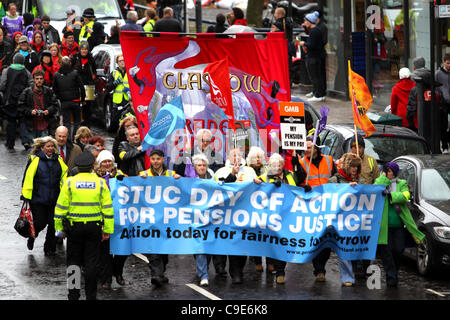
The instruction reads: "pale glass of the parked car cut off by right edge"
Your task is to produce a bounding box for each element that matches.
[421,165,450,201]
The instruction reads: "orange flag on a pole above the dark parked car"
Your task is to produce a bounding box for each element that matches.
[348,60,376,137]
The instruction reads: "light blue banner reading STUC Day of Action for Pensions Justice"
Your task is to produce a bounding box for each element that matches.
[111,177,385,263]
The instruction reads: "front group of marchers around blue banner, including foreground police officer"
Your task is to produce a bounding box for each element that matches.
[18,119,424,299]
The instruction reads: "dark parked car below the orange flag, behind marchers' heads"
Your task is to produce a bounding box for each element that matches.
[319,124,431,166]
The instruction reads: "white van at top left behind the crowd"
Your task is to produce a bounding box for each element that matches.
[22,0,125,38]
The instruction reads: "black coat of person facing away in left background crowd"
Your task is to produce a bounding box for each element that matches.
[53,67,86,102]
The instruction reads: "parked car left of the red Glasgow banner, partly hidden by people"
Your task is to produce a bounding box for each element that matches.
[92,44,122,132]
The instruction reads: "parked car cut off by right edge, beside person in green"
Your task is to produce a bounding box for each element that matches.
[394,155,450,275]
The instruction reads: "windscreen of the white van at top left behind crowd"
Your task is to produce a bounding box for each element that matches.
[38,0,120,21]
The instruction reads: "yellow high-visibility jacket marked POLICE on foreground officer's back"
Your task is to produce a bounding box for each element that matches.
[55,172,114,233]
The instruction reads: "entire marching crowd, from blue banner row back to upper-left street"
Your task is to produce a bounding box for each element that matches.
[0,1,423,299]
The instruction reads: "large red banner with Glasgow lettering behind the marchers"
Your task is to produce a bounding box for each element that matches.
[120,32,291,166]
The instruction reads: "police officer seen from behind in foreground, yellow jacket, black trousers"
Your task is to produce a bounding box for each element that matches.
[55,152,114,300]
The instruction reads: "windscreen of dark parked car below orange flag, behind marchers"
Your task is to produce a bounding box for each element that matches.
[364,136,428,163]
